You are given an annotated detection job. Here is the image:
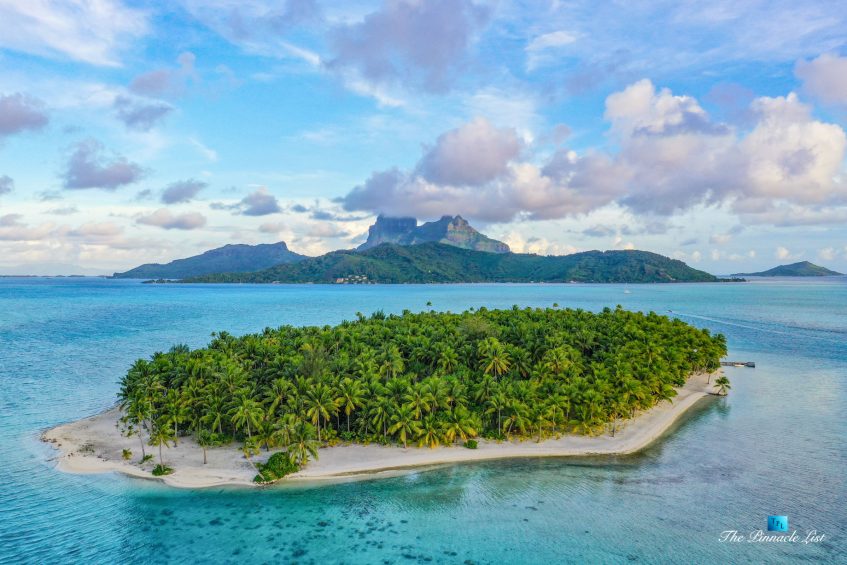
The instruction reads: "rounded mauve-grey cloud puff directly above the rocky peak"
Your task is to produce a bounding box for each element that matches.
[418,118,521,186]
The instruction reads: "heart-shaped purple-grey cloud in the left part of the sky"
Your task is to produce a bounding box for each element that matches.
[62,139,144,190]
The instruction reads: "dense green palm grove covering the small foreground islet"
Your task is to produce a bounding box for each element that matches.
[119,307,726,478]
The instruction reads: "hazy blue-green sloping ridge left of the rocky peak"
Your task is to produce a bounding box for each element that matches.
[113,241,306,279]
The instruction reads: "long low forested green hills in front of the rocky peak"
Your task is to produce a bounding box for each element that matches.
[183,243,718,283]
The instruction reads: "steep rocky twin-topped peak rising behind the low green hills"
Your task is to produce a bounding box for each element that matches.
[358,216,509,253]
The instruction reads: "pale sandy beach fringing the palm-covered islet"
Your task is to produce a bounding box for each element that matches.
[42,374,715,488]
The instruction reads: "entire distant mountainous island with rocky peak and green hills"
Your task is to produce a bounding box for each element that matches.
[113,216,740,284]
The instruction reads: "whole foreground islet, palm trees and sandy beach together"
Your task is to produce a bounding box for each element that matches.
[43,307,728,487]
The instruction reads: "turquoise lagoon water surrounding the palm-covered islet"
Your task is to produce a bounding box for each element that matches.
[0,278,847,563]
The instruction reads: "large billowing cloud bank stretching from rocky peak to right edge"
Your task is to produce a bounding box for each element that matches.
[340,80,847,225]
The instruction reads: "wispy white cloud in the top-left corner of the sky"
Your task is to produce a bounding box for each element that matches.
[0,0,148,66]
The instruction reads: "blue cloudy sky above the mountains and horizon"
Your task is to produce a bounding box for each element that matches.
[0,0,847,274]
